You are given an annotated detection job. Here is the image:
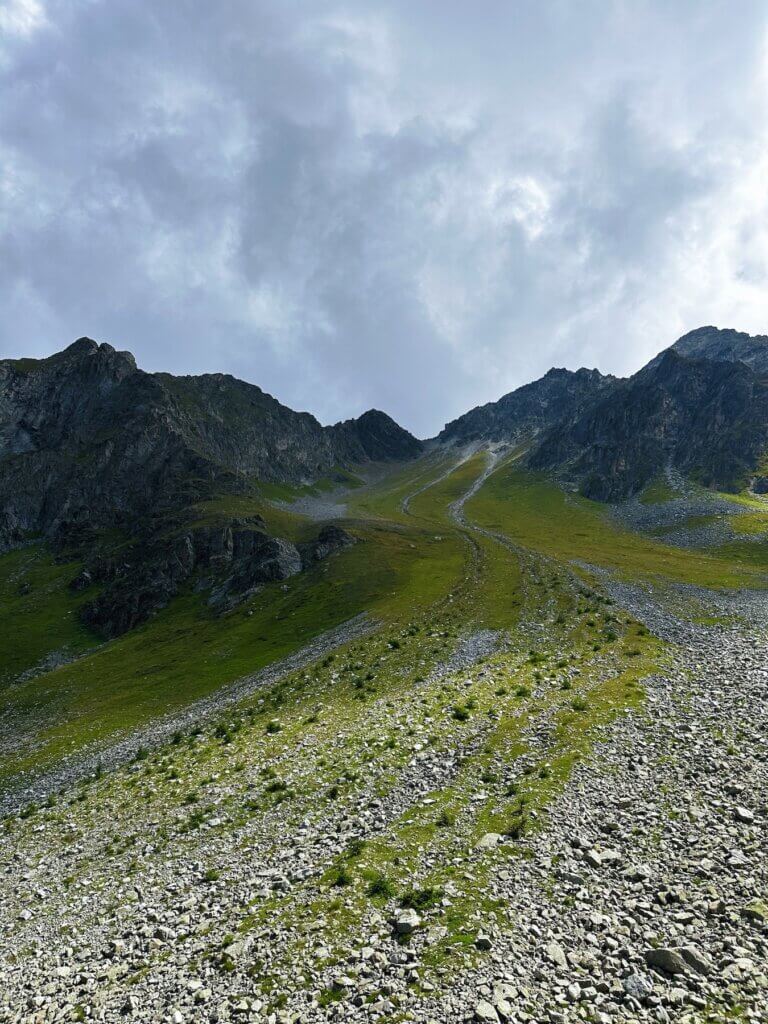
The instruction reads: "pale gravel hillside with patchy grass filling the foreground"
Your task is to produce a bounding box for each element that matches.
[0,453,768,1024]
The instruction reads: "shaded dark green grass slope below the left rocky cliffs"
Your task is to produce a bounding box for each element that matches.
[0,464,467,779]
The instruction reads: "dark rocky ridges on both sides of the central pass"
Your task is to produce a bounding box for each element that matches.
[0,327,768,636]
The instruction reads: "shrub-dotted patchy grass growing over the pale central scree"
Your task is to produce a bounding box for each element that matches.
[1,460,660,999]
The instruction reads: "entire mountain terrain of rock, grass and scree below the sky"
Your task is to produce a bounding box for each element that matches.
[0,333,768,1024]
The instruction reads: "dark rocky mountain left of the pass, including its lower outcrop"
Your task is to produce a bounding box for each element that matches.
[0,338,421,636]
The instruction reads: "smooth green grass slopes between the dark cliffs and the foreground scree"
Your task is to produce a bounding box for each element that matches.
[0,455,762,798]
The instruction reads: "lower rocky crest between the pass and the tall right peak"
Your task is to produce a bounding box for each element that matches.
[437,369,615,444]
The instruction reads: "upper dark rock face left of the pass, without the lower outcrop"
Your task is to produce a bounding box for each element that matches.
[0,338,421,551]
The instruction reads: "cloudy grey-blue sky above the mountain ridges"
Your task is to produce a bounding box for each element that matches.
[0,0,768,436]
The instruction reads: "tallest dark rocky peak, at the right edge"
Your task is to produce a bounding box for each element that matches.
[529,328,768,501]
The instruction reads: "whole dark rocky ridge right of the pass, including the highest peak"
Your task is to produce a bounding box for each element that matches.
[438,327,768,502]
